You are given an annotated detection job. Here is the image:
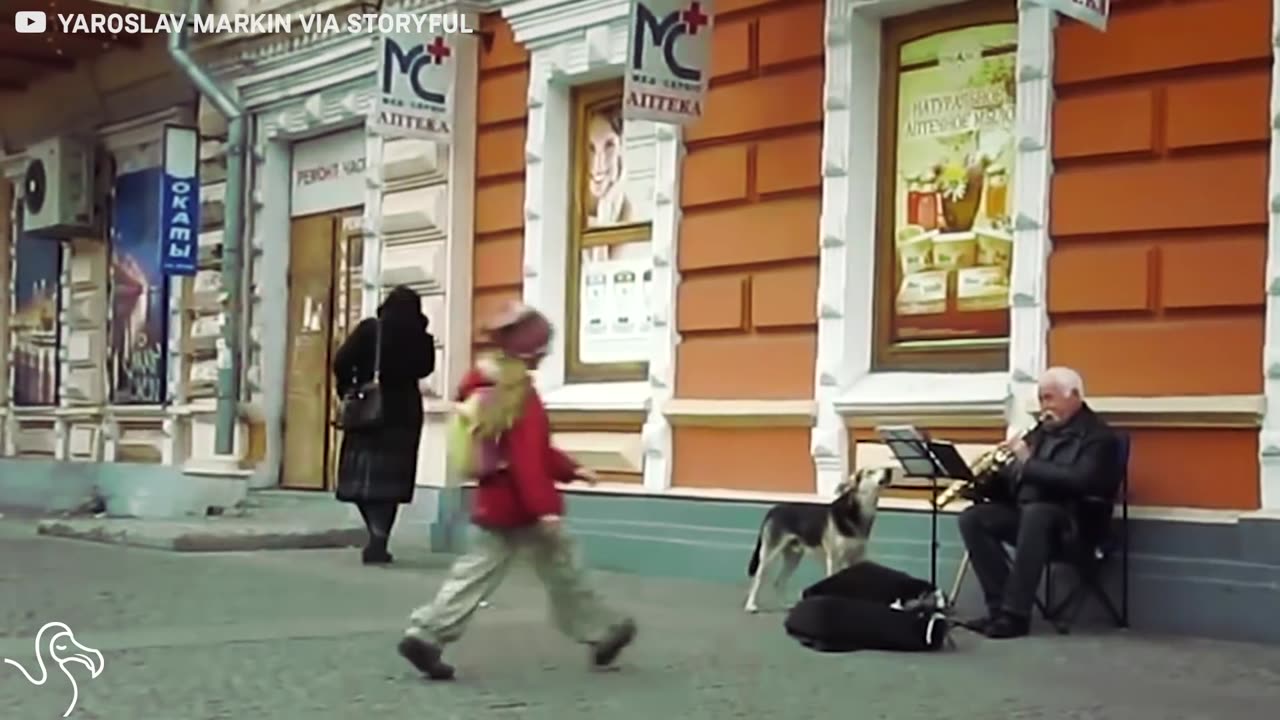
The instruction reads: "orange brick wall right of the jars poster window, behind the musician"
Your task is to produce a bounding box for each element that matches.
[1048,0,1272,507]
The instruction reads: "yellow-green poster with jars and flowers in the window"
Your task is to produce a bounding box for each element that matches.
[892,23,1018,342]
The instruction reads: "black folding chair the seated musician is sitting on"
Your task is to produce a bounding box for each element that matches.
[1039,432,1129,634]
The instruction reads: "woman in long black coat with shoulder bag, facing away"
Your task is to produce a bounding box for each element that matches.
[333,286,435,564]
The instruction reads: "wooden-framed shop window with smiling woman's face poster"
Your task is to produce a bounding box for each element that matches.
[564,82,657,382]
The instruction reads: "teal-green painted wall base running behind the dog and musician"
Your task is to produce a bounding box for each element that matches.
[433,491,1280,644]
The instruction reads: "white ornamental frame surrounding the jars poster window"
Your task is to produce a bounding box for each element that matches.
[810,0,1056,496]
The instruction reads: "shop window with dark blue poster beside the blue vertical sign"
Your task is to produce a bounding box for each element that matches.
[108,168,169,405]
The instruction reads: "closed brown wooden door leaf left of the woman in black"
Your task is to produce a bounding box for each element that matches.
[280,214,340,489]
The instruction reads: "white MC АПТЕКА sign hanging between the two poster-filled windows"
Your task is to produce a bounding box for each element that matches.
[622,0,714,126]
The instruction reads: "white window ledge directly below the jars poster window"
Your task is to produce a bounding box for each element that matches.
[836,372,1010,415]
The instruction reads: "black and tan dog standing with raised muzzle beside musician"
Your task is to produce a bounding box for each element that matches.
[745,468,895,612]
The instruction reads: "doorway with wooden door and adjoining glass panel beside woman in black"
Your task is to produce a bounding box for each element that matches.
[280,210,362,491]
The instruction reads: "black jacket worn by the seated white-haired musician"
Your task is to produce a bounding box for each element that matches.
[1009,405,1124,505]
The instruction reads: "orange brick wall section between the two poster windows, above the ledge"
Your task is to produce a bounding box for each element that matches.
[676,0,823,398]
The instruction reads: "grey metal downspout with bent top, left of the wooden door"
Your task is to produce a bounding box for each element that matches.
[169,0,246,456]
